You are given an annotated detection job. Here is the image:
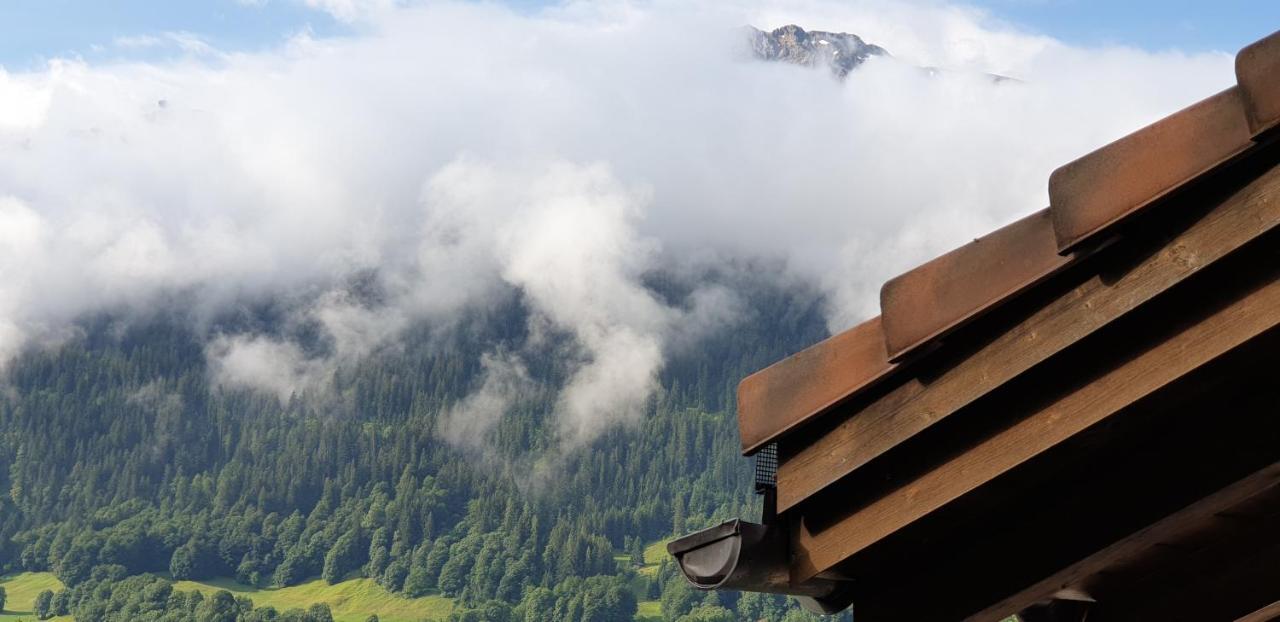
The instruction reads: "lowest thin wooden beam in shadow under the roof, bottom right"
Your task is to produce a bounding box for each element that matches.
[968,462,1280,622]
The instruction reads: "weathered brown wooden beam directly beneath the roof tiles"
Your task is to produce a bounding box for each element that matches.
[778,154,1280,512]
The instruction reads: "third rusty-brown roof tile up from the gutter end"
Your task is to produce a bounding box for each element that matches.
[1048,87,1253,251]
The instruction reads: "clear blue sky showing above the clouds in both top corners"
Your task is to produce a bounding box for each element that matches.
[0,0,1280,70]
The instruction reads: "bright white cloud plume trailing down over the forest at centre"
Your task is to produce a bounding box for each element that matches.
[495,165,677,444]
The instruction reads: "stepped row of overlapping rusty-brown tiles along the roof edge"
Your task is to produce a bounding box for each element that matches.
[739,33,1280,454]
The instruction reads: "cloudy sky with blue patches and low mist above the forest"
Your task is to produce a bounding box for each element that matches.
[0,0,1264,448]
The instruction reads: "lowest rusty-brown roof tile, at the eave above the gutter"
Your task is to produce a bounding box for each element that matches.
[737,317,893,453]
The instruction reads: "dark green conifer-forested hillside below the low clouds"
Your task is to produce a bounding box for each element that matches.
[0,281,839,621]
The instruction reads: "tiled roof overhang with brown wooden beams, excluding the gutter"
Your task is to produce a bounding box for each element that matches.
[739,27,1280,622]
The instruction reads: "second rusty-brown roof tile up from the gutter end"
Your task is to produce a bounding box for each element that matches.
[881,209,1073,361]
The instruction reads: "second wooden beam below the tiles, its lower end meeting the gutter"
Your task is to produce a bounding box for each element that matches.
[792,255,1280,580]
